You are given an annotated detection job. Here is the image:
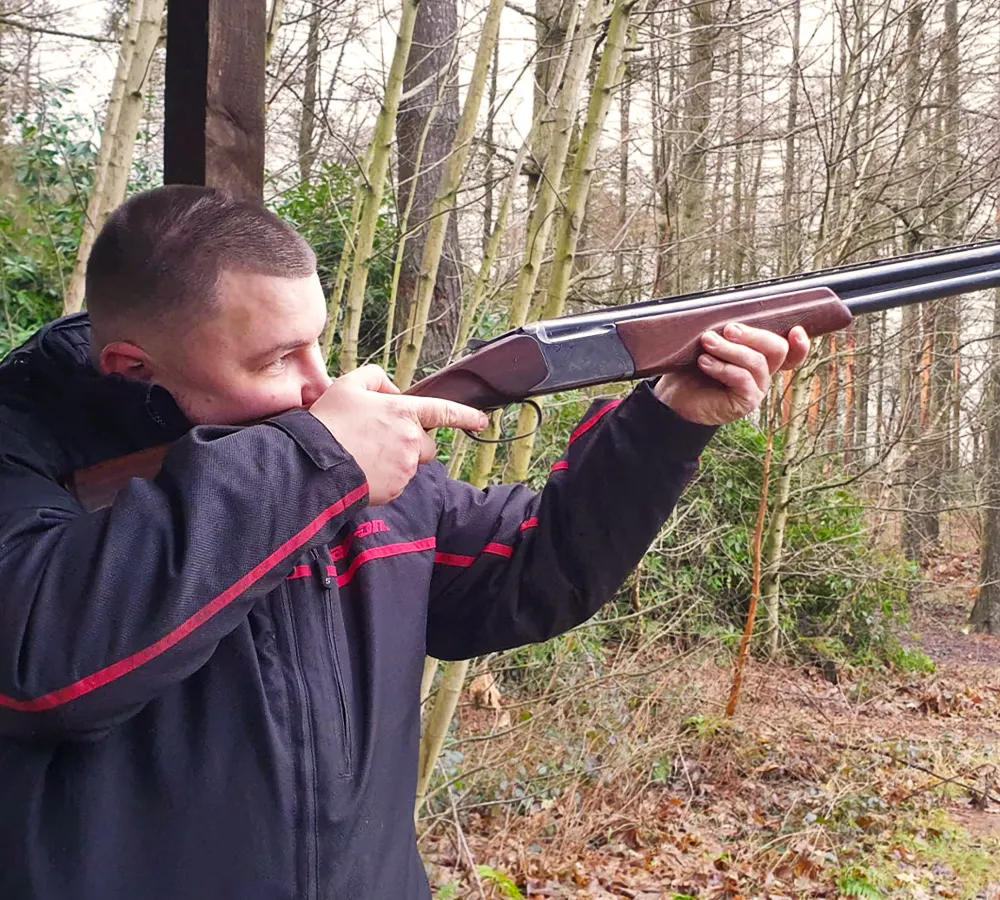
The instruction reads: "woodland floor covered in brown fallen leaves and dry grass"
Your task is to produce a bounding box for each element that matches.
[421,555,1000,900]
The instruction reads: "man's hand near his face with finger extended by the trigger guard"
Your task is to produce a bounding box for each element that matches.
[309,366,489,506]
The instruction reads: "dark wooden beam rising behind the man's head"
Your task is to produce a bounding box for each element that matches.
[163,0,266,200]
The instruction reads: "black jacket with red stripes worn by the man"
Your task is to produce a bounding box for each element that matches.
[0,316,713,900]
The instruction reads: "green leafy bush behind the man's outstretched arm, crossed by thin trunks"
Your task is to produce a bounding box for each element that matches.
[504,393,919,657]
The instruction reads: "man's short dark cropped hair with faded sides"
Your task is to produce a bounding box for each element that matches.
[86,184,316,349]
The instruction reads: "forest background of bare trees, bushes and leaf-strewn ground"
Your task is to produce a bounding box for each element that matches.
[0,0,1000,898]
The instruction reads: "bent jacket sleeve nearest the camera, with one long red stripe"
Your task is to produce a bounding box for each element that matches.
[0,411,368,738]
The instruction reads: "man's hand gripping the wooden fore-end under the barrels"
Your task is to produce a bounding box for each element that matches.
[655,324,809,425]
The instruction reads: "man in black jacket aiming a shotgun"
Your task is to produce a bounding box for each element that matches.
[0,187,808,900]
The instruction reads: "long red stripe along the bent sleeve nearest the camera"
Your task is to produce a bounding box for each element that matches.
[0,484,368,712]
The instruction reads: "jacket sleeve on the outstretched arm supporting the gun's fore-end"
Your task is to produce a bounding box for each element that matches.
[427,382,716,659]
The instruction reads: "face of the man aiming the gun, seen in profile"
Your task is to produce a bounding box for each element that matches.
[139,272,331,425]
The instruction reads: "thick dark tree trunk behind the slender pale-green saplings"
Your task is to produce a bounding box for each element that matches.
[395,0,462,367]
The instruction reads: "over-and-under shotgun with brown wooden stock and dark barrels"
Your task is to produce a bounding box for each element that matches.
[65,241,1000,510]
